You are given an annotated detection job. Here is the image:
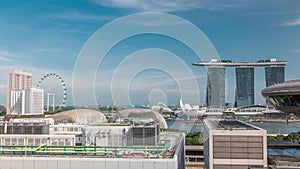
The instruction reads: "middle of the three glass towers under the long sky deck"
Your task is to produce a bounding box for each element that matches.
[235,67,254,107]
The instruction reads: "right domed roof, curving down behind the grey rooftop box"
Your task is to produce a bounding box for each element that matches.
[119,109,168,128]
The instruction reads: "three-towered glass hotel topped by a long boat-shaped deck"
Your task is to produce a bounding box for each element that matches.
[193,58,286,107]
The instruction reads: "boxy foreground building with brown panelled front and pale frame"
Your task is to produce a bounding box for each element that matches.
[203,119,268,169]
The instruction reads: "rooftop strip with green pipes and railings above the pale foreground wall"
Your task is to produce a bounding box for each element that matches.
[0,132,185,159]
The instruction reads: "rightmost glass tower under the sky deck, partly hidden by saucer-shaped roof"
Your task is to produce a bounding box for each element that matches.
[265,66,284,87]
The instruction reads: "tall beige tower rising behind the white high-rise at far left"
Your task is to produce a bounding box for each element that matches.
[6,70,32,114]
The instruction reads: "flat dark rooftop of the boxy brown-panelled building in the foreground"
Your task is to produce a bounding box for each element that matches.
[204,119,261,131]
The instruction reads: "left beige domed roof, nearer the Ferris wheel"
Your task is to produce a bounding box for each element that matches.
[51,109,107,124]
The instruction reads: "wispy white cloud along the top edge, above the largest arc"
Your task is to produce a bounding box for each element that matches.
[91,0,237,12]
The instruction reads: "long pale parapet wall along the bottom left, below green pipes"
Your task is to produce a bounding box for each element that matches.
[0,157,178,169]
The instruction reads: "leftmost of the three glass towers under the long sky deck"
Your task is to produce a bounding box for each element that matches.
[206,66,225,107]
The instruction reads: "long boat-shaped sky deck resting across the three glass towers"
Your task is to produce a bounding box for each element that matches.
[193,58,286,67]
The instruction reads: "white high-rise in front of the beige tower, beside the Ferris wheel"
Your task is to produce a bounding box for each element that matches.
[9,88,44,115]
